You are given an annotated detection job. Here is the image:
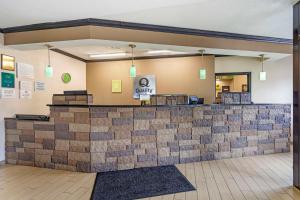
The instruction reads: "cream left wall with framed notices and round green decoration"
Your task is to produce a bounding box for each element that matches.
[0,33,86,161]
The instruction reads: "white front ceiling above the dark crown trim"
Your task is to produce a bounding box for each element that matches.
[0,0,295,38]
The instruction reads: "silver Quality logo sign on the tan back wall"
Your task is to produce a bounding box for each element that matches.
[133,75,156,99]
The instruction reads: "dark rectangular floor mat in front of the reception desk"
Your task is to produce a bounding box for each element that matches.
[91,166,195,200]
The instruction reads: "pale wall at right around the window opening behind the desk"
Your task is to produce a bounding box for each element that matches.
[215,55,293,103]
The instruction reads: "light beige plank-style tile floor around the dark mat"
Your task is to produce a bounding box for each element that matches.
[0,153,300,200]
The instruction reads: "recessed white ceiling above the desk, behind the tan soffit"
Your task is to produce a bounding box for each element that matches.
[10,39,290,60]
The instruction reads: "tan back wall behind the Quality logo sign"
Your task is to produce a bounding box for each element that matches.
[87,56,215,105]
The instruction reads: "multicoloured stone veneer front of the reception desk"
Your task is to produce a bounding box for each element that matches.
[5,104,291,172]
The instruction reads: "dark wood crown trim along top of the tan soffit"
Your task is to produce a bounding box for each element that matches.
[2,18,292,44]
